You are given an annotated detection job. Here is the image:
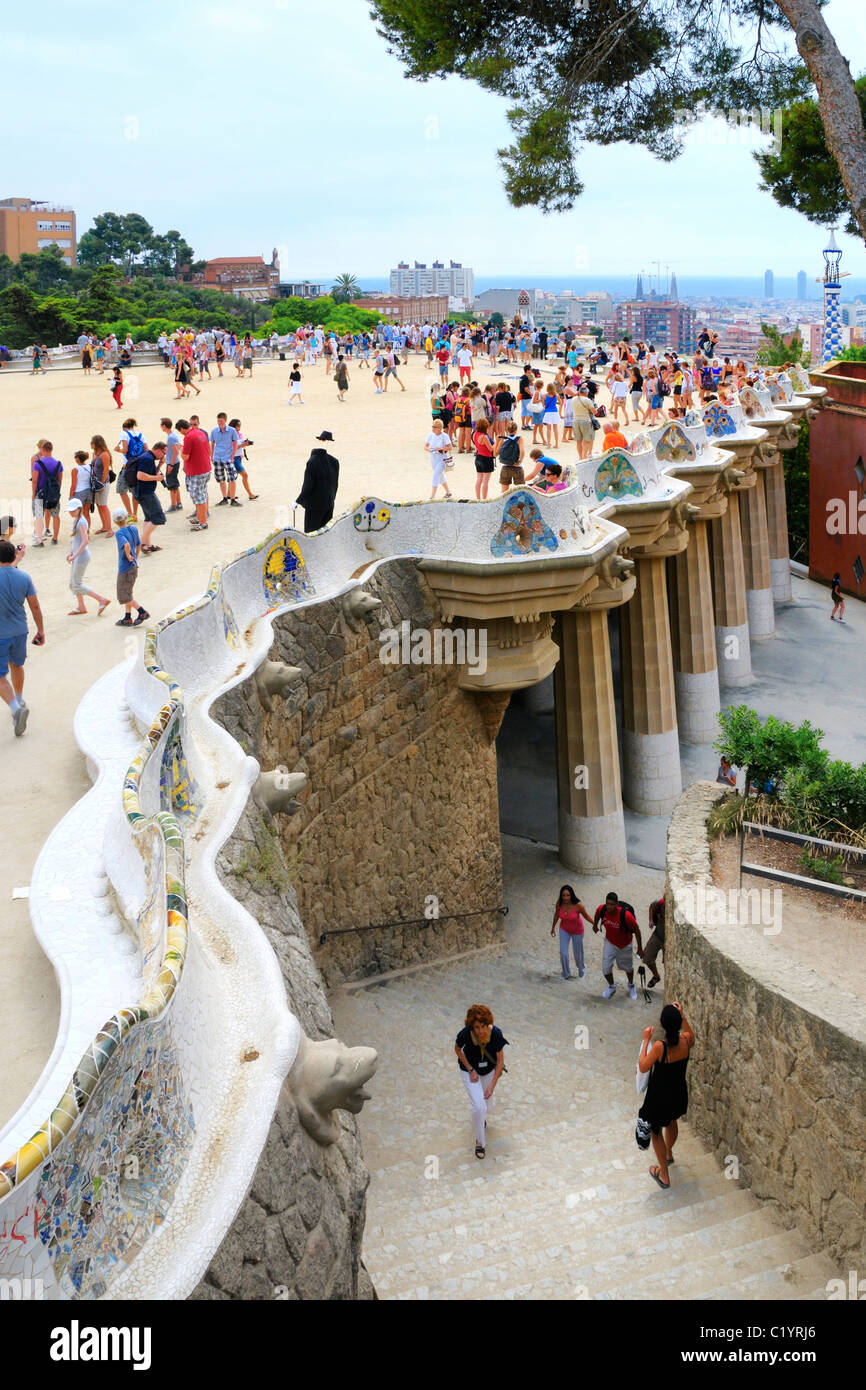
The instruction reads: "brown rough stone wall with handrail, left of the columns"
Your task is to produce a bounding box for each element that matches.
[215,560,505,987]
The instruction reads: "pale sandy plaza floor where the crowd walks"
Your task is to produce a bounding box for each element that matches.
[0,354,622,1125]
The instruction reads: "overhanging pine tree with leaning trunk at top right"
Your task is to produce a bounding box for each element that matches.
[371,0,866,236]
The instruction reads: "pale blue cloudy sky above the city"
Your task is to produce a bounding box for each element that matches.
[6,0,866,288]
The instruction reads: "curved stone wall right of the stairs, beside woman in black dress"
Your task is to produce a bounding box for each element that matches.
[664,783,866,1269]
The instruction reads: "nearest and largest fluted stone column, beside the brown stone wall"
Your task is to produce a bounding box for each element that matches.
[553,607,627,874]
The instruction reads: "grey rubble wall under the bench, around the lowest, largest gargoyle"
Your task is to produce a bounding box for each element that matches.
[192,803,375,1300]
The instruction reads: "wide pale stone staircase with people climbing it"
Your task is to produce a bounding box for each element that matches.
[331,937,838,1300]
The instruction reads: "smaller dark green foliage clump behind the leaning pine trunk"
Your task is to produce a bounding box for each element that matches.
[755,78,866,236]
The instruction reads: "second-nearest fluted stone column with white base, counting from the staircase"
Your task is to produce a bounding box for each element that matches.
[620,550,683,816]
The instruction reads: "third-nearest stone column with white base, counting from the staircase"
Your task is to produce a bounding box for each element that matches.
[669,517,720,744]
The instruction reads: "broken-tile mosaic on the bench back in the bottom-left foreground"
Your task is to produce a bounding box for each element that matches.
[33,1023,195,1298]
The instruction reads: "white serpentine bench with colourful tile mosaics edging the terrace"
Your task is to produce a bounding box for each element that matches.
[0,394,817,1300]
